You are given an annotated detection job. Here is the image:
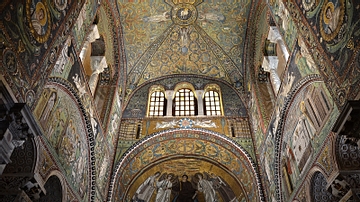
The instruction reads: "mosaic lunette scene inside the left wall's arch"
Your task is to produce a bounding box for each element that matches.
[34,85,89,200]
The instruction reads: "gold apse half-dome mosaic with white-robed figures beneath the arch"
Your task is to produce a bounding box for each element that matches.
[126,158,246,202]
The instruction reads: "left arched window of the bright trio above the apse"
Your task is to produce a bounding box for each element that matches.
[148,86,166,117]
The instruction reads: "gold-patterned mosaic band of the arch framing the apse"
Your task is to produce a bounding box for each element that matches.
[113,130,259,201]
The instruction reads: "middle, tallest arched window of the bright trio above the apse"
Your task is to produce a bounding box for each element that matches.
[173,83,198,116]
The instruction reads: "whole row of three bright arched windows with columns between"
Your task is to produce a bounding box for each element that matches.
[147,82,223,117]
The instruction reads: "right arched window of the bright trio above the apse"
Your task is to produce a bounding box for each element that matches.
[203,84,222,116]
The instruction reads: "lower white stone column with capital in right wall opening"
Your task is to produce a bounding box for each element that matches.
[262,56,281,94]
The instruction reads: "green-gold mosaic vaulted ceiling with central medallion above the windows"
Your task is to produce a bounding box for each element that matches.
[117,0,251,89]
